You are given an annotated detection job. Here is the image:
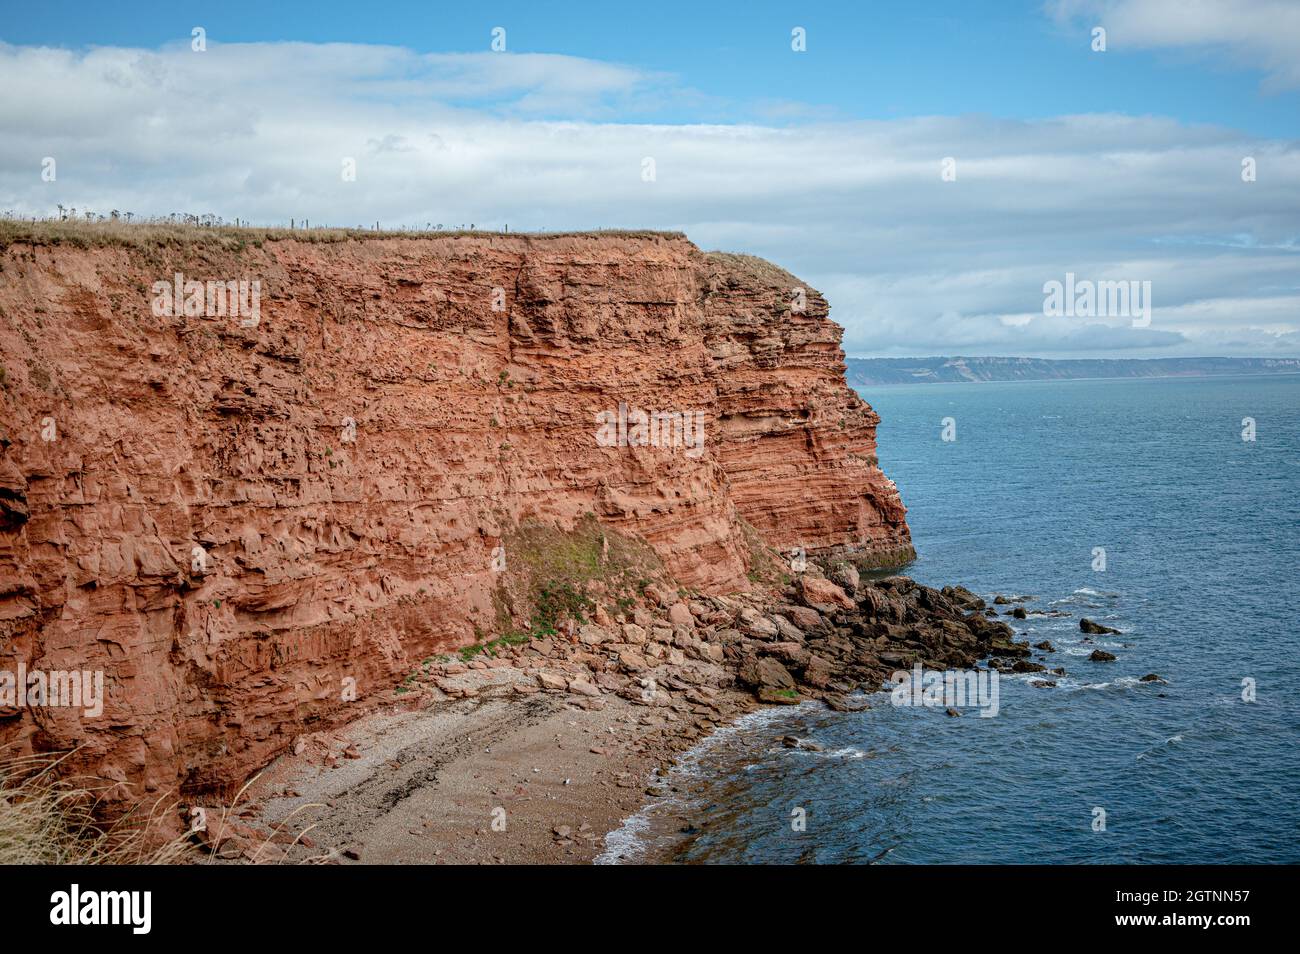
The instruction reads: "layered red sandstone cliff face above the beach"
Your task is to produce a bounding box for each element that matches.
[0,235,910,798]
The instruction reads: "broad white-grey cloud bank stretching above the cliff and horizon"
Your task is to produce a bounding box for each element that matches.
[0,43,1300,356]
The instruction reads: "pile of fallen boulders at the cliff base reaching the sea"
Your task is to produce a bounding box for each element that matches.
[415,561,1031,717]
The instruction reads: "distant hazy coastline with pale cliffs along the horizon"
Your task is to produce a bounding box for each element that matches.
[846,357,1300,387]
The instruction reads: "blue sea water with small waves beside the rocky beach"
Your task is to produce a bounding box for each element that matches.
[605,376,1300,864]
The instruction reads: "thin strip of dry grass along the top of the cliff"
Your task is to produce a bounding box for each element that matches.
[0,217,685,251]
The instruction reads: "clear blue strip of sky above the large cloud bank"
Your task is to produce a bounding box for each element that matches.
[0,0,1300,138]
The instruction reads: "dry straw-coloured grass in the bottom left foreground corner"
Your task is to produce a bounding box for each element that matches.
[0,755,192,864]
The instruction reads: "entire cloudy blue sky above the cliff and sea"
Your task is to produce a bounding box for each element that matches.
[0,0,1300,357]
